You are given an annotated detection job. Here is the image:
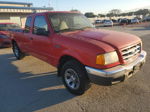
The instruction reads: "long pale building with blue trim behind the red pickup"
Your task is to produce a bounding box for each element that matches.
[0,1,53,27]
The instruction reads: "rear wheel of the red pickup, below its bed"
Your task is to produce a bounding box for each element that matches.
[12,42,25,60]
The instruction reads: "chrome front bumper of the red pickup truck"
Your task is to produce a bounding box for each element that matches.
[85,51,147,82]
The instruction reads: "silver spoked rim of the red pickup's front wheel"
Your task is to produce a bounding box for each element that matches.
[64,69,80,90]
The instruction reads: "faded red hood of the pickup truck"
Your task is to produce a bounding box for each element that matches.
[63,29,141,49]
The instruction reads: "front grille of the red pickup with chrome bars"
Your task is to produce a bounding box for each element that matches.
[121,43,141,61]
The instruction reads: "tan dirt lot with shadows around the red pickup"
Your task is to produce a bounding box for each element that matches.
[0,27,150,112]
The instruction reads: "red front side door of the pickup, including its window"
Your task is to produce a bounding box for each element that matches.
[31,15,52,61]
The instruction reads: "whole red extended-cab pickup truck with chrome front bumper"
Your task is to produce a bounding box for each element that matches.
[12,12,146,94]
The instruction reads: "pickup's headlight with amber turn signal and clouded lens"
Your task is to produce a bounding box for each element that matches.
[96,51,119,65]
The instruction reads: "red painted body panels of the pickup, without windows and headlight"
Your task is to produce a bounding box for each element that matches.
[13,12,141,69]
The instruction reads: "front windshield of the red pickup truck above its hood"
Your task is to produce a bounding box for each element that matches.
[49,13,94,32]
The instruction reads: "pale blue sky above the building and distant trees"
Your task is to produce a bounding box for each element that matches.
[2,0,150,14]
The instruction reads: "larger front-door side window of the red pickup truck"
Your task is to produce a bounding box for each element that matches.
[33,16,49,36]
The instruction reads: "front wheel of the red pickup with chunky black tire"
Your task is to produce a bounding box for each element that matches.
[60,60,90,95]
